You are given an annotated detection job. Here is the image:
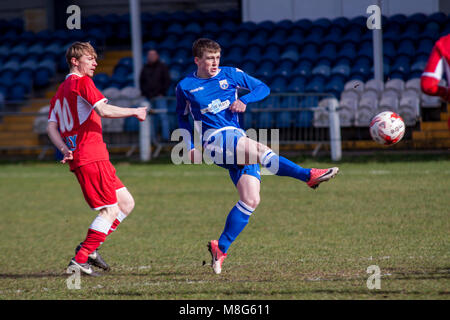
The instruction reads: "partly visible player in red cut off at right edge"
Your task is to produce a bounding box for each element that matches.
[420,34,450,130]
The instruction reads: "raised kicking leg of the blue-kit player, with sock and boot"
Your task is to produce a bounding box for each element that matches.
[236,137,339,189]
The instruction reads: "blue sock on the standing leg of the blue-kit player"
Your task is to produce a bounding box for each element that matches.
[219,200,255,253]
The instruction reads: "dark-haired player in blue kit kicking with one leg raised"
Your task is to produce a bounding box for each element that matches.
[176,38,339,274]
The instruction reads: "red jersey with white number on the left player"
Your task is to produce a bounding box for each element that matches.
[48,73,109,171]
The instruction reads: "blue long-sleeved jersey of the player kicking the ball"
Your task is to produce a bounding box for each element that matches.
[176,67,270,148]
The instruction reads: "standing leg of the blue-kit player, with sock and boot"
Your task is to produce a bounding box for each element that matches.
[208,174,260,274]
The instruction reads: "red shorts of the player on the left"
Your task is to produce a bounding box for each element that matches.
[74,160,125,210]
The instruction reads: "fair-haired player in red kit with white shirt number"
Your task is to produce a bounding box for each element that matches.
[47,42,147,275]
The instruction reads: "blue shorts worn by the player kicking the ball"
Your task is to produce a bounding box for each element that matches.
[204,127,261,185]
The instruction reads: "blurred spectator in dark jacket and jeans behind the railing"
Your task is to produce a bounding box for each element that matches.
[139,49,170,140]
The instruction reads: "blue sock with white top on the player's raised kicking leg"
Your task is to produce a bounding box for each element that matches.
[260,150,311,182]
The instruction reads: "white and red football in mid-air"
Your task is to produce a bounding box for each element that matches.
[370,111,405,146]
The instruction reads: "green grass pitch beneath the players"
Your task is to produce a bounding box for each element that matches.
[0,156,450,300]
